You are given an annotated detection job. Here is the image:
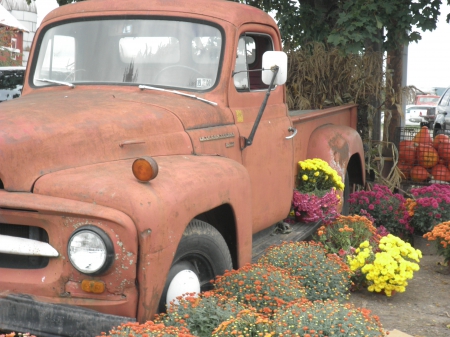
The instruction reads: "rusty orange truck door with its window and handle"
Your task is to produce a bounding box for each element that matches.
[229,25,294,233]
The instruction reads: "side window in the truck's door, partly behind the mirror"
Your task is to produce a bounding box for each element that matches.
[233,33,273,91]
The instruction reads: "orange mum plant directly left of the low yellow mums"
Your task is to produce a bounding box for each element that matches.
[258,241,351,301]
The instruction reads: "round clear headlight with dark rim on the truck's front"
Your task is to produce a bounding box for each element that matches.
[67,226,114,275]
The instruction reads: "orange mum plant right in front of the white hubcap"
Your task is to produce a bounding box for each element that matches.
[154,291,246,337]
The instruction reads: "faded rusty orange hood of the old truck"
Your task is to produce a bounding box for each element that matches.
[0,87,224,191]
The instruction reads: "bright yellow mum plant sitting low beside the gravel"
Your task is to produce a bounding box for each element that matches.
[347,234,422,296]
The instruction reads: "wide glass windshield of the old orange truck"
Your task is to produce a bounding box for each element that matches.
[33,18,222,91]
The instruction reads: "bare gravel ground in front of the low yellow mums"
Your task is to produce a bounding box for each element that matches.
[350,248,450,337]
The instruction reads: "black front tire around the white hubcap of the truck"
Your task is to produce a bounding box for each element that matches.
[158,219,233,312]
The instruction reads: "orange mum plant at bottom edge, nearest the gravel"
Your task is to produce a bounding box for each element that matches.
[273,300,385,337]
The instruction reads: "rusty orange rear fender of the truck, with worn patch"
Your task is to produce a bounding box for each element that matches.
[307,124,365,184]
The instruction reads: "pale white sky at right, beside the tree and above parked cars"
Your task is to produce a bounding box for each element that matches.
[406,0,450,91]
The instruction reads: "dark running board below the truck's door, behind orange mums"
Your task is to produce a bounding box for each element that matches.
[252,221,322,263]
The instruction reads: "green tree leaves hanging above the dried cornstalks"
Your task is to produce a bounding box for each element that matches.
[242,0,441,53]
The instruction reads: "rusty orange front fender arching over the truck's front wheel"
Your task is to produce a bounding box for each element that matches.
[35,155,252,321]
